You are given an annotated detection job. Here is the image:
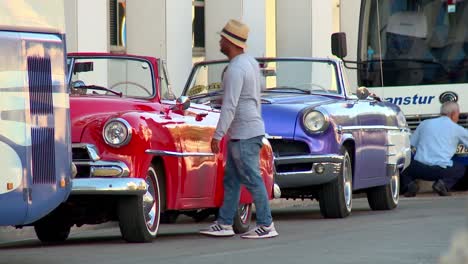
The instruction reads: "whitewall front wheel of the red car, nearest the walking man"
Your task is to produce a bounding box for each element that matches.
[118,165,164,242]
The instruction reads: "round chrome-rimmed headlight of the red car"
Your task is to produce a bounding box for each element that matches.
[102,118,132,148]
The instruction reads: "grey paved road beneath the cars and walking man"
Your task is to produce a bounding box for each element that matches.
[0,194,468,264]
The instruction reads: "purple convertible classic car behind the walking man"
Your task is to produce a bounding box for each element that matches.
[183,55,410,218]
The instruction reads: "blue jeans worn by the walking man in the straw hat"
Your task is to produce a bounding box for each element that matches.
[217,136,273,226]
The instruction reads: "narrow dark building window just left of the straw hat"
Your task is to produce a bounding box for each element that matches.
[192,0,205,57]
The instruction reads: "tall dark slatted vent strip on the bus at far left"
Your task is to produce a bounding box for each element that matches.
[28,57,57,184]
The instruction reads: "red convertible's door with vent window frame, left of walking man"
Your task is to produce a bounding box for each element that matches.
[159,63,220,206]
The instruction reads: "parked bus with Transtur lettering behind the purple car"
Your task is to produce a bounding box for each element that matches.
[334,0,468,159]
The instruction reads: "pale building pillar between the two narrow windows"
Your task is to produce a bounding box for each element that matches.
[127,0,192,95]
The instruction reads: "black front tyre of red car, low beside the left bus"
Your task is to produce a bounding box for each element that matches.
[34,220,71,243]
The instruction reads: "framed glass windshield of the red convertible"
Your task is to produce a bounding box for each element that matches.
[68,58,154,98]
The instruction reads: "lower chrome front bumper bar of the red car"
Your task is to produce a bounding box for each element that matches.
[71,178,148,195]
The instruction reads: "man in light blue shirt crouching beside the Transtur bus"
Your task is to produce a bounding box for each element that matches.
[401,102,468,197]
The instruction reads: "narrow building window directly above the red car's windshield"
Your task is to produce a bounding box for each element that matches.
[109,0,127,50]
